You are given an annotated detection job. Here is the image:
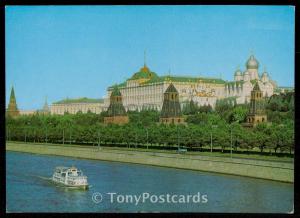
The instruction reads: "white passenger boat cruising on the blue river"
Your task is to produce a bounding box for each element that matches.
[52,166,88,189]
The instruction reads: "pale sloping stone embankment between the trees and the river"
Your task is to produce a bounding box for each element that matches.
[6,142,294,183]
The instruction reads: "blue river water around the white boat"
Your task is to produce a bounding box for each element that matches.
[6,152,294,213]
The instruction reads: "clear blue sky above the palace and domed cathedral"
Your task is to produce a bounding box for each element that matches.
[5,6,295,110]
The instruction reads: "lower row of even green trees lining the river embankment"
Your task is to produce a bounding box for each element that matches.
[6,111,294,156]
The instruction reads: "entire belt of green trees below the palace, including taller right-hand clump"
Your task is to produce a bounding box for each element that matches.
[6,93,294,155]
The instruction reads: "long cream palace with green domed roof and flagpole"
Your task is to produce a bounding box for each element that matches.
[104,65,225,111]
